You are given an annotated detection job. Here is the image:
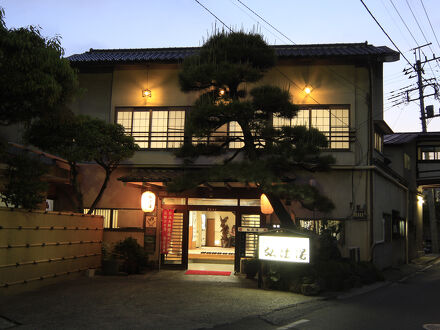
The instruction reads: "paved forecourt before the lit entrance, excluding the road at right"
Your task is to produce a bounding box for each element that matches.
[0,271,317,329]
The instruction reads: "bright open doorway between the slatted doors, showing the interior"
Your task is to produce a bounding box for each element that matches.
[188,210,236,272]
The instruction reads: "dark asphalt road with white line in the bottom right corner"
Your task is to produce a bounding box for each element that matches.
[209,263,440,330]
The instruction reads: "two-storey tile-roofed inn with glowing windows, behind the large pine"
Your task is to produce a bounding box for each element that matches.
[37,43,422,270]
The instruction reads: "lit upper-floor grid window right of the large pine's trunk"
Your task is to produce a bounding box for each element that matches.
[273,107,350,149]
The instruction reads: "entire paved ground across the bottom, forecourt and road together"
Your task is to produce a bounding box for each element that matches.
[0,263,440,330]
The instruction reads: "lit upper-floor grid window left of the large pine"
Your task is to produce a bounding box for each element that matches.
[116,108,185,149]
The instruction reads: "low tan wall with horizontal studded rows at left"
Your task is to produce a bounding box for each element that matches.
[0,208,103,295]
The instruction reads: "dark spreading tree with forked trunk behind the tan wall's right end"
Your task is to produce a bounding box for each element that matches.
[26,111,138,214]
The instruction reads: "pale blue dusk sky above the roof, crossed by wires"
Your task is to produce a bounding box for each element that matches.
[0,0,440,132]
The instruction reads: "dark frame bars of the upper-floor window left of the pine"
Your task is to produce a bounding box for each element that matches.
[114,106,187,150]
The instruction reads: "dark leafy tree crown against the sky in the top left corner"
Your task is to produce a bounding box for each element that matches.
[0,8,78,125]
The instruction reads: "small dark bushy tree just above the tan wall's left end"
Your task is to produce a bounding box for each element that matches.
[1,153,47,209]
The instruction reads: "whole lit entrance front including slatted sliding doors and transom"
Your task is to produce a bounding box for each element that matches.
[161,197,266,272]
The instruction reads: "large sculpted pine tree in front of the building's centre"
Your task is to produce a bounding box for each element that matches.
[168,32,333,227]
